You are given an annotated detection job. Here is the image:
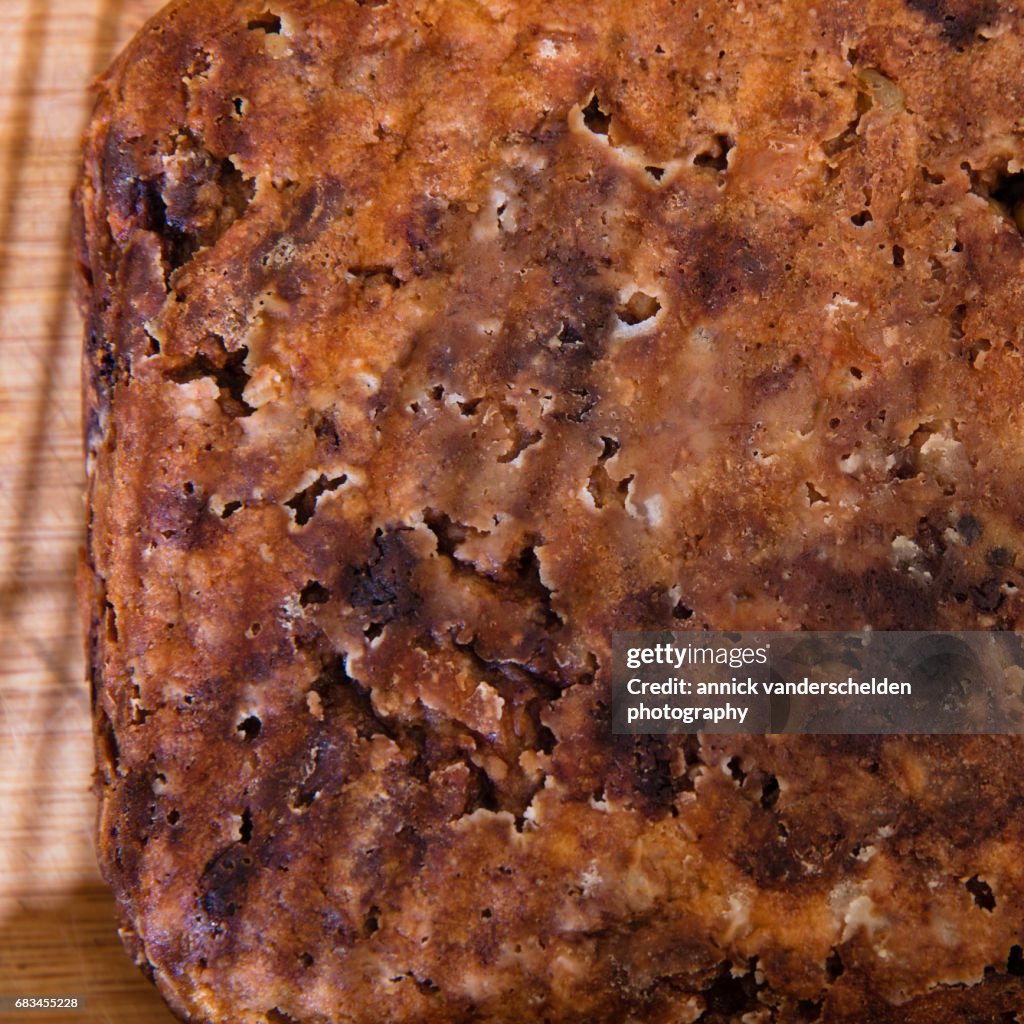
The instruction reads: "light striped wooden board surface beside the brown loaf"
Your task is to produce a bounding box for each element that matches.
[0,0,174,1024]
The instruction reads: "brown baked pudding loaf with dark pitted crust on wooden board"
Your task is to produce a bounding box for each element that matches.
[77,0,1024,1024]
